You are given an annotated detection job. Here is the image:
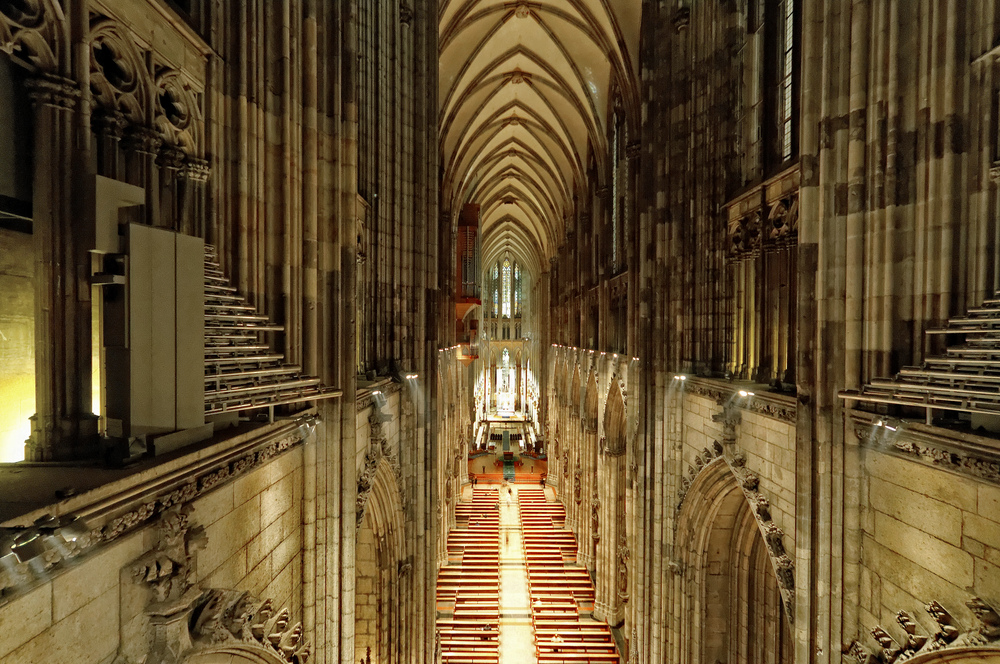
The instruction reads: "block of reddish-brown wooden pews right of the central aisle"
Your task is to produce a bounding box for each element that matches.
[518,487,621,664]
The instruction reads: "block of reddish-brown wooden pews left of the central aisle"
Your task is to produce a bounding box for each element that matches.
[437,487,500,664]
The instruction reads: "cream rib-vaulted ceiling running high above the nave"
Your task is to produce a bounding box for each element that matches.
[439,0,642,277]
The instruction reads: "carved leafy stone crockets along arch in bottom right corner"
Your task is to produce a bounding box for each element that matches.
[845,597,1000,664]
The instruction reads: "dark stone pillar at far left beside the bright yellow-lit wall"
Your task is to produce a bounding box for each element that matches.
[25,74,97,461]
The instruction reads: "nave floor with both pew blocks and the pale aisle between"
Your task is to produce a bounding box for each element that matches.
[437,484,621,664]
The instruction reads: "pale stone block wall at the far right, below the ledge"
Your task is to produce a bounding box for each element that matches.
[859,450,1000,634]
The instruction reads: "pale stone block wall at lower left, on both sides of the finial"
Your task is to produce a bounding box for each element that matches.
[0,446,303,664]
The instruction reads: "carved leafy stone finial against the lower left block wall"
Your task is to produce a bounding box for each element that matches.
[132,505,206,602]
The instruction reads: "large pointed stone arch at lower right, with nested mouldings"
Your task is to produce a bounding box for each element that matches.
[670,456,793,664]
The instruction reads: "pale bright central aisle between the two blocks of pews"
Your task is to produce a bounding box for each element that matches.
[500,486,537,664]
